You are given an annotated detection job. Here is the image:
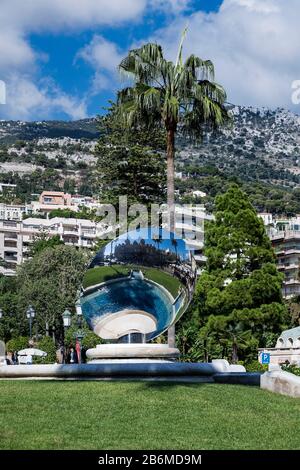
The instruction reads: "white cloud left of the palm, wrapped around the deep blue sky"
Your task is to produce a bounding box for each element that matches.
[0,0,147,119]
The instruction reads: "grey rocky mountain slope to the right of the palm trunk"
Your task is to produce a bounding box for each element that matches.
[179,106,300,186]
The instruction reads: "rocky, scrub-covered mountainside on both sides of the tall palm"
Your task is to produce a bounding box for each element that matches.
[0,106,300,214]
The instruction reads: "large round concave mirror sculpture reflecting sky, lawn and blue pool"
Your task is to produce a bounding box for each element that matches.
[80,228,197,343]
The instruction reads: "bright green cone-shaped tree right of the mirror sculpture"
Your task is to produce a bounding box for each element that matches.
[185,185,290,362]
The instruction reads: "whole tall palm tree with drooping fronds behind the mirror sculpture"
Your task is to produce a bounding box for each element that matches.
[117,30,230,344]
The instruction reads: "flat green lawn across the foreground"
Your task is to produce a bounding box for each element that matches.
[0,381,300,450]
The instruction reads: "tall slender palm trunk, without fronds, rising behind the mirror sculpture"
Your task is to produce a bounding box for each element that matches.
[167,126,175,348]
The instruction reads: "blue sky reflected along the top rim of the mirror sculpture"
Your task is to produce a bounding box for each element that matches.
[102,227,190,261]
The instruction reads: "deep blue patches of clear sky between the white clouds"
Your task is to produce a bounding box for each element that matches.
[29,0,222,115]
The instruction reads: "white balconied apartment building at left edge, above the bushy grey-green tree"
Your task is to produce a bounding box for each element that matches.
[0,217,110,276]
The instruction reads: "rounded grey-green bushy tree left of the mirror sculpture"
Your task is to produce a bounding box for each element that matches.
[16,245,88,339]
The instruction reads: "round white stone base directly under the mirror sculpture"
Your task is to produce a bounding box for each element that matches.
[86,343,180,363]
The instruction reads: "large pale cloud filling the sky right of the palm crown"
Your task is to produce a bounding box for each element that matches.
[152,0,300,108]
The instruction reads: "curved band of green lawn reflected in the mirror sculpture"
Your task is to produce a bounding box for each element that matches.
[83,265,180,298]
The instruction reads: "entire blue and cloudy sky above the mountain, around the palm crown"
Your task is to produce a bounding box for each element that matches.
[0,0,300,121]
